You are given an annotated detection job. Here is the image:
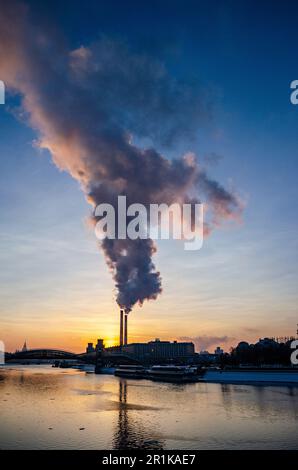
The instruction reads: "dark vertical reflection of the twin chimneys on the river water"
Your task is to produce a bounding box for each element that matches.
[113,379,163,450]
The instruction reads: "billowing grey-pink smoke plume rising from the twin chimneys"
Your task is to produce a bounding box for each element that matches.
[0,1,241,311]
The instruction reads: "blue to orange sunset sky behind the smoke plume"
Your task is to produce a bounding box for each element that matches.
[0,0,298,352]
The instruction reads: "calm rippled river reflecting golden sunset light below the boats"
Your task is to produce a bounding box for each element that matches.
[0,365,298,450]
